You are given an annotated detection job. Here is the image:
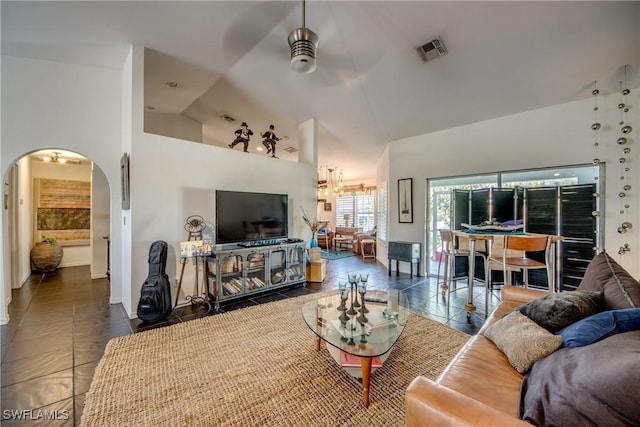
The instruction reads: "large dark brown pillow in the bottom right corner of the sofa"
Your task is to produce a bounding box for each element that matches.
[518,331,640,427]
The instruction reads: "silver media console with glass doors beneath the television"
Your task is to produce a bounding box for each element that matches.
[207,242,306,310]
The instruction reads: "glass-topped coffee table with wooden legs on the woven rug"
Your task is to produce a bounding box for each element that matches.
[302,289,409,407]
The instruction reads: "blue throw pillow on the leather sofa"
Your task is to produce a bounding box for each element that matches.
[556,308,640,348]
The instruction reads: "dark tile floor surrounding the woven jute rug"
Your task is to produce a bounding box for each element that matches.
[0,256,497,426]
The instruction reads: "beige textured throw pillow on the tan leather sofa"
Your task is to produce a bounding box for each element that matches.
[484,311,562,374]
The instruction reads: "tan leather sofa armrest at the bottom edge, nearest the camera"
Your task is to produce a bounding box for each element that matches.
[405,377,531,427]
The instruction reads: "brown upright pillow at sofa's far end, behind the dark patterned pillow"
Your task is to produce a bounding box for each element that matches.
[578,252,640,310]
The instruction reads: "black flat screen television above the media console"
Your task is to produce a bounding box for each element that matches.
[216,190,289,244]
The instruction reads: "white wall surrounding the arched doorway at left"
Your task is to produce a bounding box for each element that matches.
[0,55,122,322]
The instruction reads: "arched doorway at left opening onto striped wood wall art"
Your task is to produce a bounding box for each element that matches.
[3,148,111,318]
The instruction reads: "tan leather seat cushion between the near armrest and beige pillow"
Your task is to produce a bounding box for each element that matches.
[437,335,522,417]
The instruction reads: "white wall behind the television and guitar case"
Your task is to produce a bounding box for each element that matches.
[127,134,316,313]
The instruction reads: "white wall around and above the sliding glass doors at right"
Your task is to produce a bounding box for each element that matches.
[379,89,640,277]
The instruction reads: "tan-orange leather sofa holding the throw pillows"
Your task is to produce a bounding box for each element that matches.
[405,286,547,427]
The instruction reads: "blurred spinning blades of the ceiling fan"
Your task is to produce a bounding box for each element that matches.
[222,0,382,87]
